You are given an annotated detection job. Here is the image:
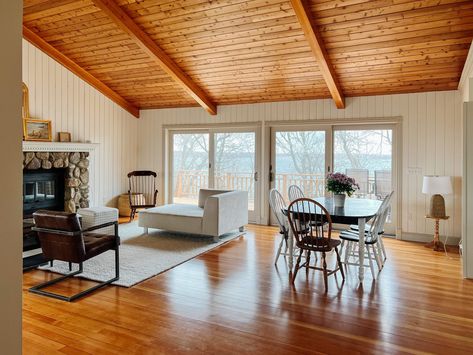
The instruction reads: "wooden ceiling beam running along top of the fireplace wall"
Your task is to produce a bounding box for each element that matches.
[23,26,140,118]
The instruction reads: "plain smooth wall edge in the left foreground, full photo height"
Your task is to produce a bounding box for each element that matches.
[0,1,23,355]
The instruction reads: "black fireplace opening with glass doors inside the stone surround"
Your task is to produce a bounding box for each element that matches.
[23,169,66,218]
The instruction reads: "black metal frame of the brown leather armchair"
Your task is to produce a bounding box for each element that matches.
[29,221,120,302]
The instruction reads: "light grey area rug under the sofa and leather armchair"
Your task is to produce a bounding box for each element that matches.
[40,221,244,287]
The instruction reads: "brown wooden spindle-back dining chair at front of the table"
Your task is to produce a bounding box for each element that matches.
[287,198,345,292]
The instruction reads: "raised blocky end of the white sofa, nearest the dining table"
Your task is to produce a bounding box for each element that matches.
[202,191,248,236]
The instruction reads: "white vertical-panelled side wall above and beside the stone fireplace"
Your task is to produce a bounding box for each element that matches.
[23,40,139,205]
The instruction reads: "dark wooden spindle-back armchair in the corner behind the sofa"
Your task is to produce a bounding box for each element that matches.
[128,170,158,222]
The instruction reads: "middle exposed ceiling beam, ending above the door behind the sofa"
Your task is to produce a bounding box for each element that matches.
[93,0,217,115]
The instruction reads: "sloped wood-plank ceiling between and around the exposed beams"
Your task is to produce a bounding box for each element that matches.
[23,0,473,117]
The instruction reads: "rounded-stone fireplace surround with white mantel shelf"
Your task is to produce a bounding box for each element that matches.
[23,142,96,212]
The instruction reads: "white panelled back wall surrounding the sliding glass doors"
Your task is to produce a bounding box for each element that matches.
[138,91,462,241]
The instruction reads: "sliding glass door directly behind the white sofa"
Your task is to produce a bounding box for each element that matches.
[169,129,259,221]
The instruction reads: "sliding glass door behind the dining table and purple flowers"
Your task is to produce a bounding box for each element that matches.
[270,124,397,234]
